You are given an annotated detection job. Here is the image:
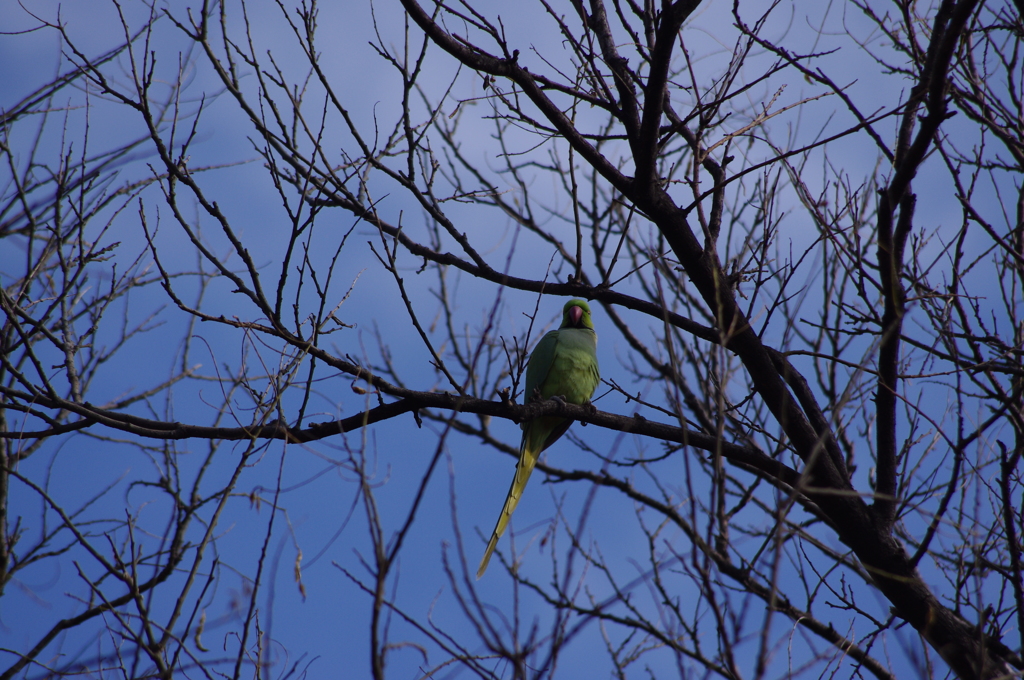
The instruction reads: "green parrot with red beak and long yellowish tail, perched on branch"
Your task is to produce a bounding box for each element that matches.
[476,300,601,579]
